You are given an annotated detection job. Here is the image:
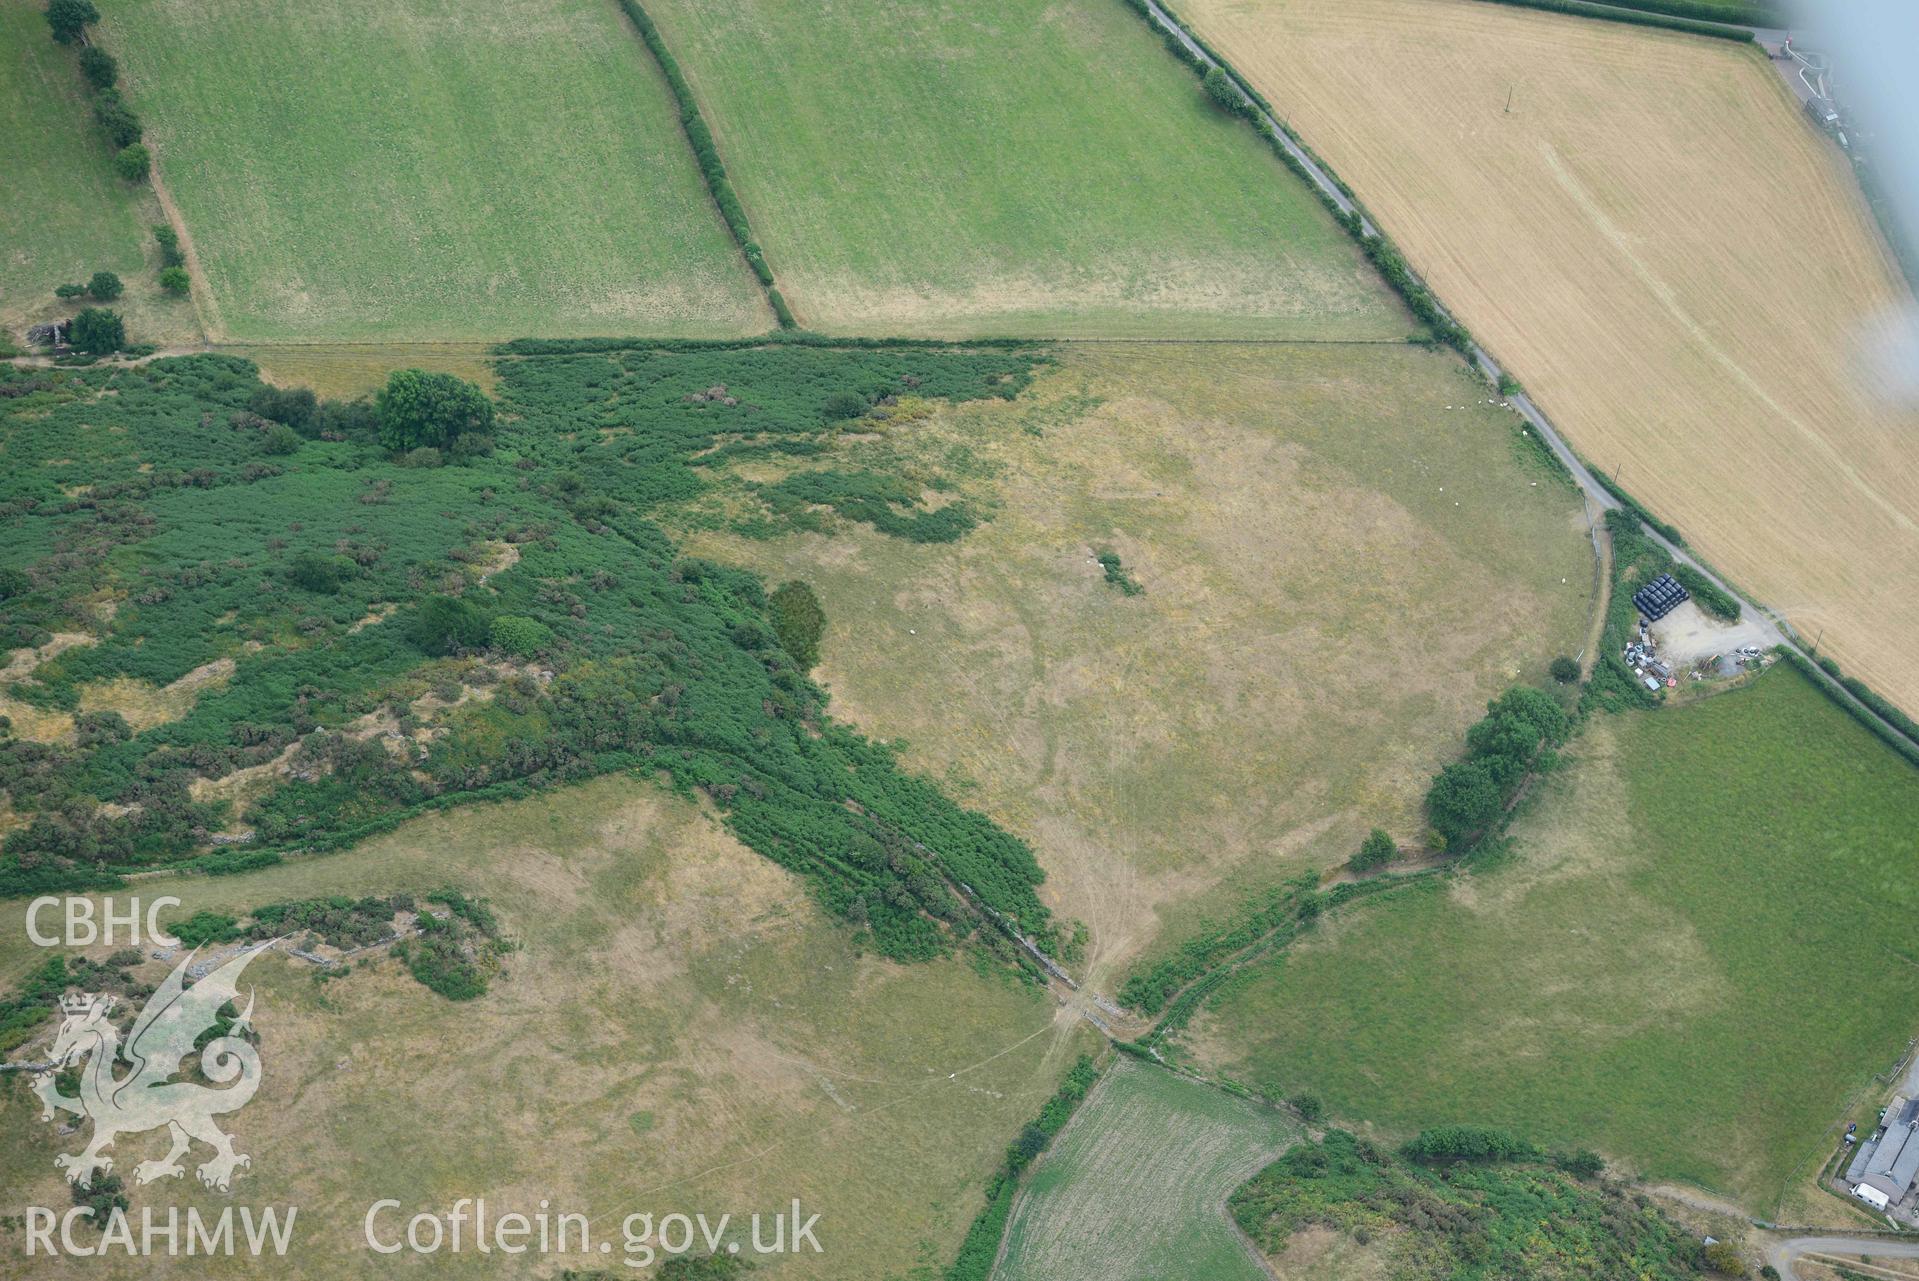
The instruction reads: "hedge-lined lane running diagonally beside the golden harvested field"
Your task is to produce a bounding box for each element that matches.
[1125,0,1919,767]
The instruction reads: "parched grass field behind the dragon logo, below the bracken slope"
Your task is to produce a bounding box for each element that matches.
[0,779,1090,1281]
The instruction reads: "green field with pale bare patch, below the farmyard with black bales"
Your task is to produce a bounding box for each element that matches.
[1194,667,1919,1214]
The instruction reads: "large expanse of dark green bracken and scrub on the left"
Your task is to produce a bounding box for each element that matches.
[0,350,1054,959]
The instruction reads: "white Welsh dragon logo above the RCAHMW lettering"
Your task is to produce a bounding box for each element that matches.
[35,943,271,1191]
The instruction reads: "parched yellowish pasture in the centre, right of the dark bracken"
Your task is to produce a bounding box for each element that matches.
[685,343,1593,984]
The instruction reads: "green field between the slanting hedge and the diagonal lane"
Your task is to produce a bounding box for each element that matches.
[649,0,1414,338]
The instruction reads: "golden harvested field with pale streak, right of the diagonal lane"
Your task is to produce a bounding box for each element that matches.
[1180,0,1919,710]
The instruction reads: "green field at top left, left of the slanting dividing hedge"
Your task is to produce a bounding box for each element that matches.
[102,0,771,339]
